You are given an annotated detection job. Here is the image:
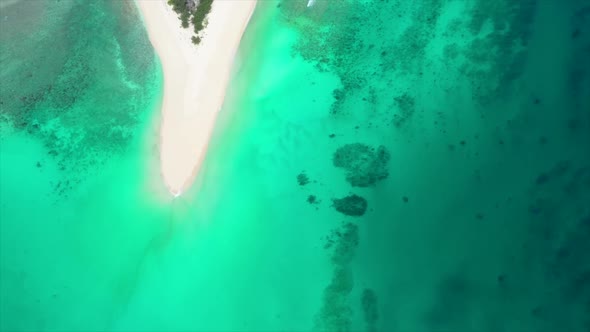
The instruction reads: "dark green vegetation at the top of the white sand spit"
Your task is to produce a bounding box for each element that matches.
[168,0,213,45]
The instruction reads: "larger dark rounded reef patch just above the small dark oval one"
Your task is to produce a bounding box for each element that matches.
[332,143,390,187]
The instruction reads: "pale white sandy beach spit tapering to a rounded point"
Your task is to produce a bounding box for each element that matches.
[137,0,256,196]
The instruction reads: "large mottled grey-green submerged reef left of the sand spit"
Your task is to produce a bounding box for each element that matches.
[0,1,160,198]
